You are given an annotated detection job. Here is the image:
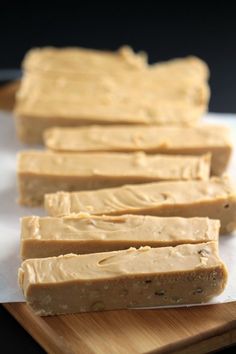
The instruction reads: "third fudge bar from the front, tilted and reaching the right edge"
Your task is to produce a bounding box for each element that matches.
[45,177,236,233]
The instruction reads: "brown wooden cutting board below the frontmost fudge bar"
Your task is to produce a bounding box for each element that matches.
[4,302,236,354]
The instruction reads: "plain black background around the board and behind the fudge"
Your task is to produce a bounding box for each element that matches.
[0,0,236,354]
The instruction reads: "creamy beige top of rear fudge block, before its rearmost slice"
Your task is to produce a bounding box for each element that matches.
[15,71,209,125]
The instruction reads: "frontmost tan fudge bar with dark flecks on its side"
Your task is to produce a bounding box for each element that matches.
[18,242,227,316]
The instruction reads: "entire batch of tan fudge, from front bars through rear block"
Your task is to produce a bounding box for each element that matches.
[15,47,236,315]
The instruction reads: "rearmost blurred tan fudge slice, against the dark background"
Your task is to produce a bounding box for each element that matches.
[23,46,209,80]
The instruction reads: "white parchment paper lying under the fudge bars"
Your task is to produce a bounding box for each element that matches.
[0,111,236,305]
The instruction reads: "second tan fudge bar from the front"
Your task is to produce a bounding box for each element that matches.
[21,214,220,259]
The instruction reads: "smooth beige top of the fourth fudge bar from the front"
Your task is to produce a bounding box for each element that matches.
[18,150,210,180]
